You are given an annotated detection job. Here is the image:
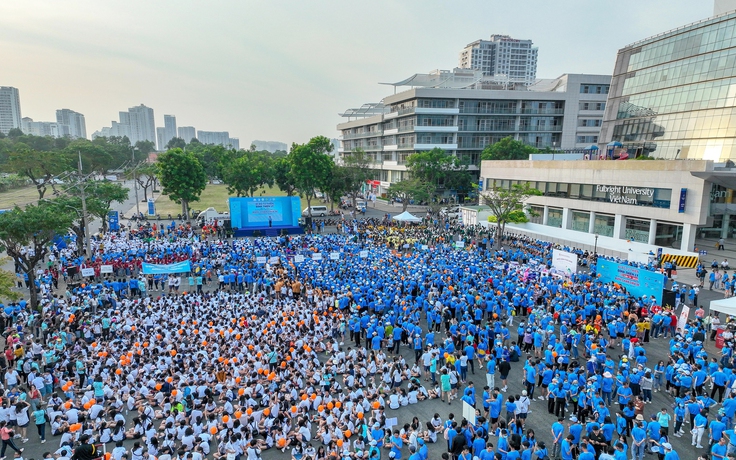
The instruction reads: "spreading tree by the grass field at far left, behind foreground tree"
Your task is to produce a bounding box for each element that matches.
[6,144,71,199]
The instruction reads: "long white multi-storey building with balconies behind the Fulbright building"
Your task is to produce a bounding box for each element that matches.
[337,69,611,194]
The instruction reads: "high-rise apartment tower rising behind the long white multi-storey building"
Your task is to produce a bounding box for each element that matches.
[459,35,537,85]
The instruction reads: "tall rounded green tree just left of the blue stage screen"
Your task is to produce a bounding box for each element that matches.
[156,149,207,216]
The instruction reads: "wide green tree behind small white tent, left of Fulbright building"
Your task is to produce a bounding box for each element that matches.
[406,148,472,212]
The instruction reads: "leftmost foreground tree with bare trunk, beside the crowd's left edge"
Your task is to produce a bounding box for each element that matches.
[0,201,74,310]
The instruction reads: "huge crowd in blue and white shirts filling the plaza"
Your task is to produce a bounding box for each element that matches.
[0,220,724,460]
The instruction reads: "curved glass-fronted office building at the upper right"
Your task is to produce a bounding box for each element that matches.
[601,11,736,162]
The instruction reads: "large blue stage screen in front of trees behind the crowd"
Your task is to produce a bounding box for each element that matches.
[230,196,301,228]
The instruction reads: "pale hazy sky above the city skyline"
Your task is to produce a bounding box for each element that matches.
[0,0,713,147]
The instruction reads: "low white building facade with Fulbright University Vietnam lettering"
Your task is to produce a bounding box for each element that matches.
[481,160,720,251]
